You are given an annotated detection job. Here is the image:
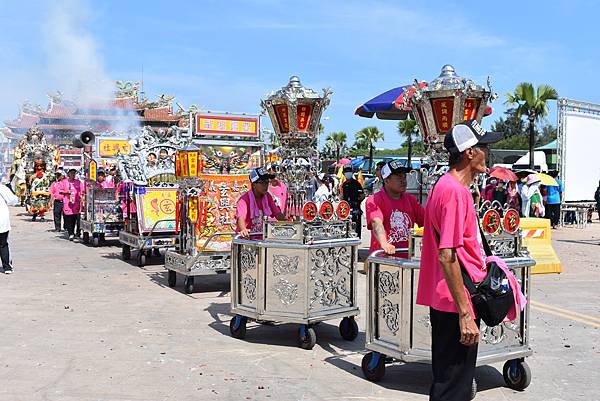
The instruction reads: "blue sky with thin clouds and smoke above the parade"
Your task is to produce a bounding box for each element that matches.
[0,0,600,148]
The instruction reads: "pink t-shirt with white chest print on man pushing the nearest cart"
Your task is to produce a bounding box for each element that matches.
[365,188,425,253]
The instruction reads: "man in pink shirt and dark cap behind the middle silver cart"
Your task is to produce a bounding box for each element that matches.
[235,167,285,237]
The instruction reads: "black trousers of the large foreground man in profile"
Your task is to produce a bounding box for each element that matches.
[429,308,479,401]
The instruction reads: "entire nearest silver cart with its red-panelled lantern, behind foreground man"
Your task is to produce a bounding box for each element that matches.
[362,65,535,397]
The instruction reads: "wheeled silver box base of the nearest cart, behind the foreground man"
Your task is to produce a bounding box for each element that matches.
[362,247,535,390]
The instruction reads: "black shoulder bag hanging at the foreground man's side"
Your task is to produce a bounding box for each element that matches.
[460,227,515,327]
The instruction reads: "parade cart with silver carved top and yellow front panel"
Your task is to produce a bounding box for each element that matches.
[118,127,184,266]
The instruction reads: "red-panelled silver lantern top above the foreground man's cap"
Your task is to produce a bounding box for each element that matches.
[410,64,496,146]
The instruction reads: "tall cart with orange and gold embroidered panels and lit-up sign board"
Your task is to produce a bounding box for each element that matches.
[165,112,264,294]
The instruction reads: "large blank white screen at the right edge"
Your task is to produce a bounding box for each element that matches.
[561,111,600,202]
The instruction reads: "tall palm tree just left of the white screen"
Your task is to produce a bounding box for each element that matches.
[505,82,558,169]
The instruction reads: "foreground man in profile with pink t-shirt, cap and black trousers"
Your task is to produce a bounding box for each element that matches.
[417,120,502,401]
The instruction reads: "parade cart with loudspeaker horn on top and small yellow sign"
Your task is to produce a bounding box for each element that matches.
[80,131,130,247]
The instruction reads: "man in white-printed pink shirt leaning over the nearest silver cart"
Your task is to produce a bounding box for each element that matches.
[366,160,425,257]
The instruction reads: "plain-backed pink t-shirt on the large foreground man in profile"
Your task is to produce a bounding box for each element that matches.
[417,173,487,312]
